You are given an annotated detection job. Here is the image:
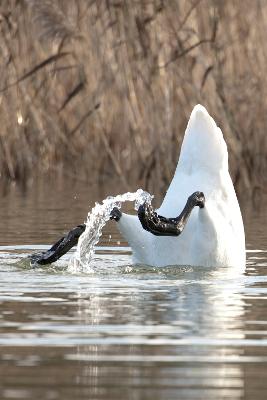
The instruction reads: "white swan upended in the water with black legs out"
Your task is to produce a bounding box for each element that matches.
[33,105,245,267]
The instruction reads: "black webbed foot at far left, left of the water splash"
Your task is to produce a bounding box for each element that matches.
[30,224,85,265]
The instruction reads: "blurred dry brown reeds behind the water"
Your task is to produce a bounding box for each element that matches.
[0,0,267,195]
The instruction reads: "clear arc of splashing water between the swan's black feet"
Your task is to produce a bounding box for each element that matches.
[69,189,153,273]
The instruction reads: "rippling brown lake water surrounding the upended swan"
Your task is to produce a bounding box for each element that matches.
[0,182,267,400]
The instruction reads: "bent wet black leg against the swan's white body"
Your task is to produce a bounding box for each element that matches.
[138,192,205,236]
